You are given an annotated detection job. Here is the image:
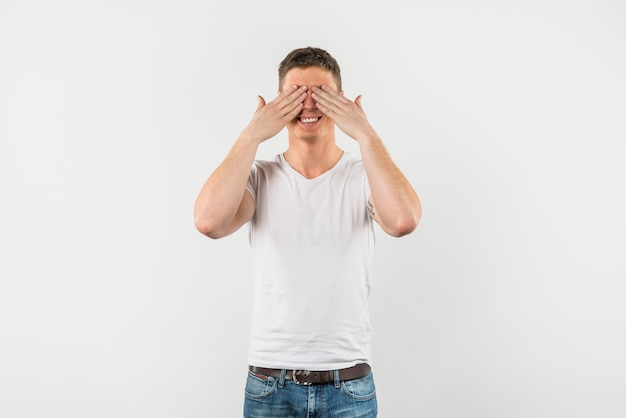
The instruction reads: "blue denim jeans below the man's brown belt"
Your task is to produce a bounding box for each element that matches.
[243,370,378,418]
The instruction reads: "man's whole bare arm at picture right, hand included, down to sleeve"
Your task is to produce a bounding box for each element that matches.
[313,86,422,237]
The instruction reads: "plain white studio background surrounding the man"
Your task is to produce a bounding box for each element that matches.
[0,0,626,418]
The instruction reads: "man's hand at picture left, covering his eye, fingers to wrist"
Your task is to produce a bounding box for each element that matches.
[244,86,307,143]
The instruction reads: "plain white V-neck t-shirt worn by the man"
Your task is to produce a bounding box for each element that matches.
[247,153,374,370]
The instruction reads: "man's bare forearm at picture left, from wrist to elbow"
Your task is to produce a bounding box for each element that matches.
[194,134,259,236]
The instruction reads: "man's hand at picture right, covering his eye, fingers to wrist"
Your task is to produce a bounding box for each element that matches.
[313,85,375,141]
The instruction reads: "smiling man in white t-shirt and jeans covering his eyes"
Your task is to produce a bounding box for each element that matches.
[194,47,421,418]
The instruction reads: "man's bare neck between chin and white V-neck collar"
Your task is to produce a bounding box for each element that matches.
[283,141,343,179]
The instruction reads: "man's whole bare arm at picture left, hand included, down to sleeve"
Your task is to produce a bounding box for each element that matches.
[194,86,306,238]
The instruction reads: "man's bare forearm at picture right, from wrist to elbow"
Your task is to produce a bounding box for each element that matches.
[358,131,422,236]
